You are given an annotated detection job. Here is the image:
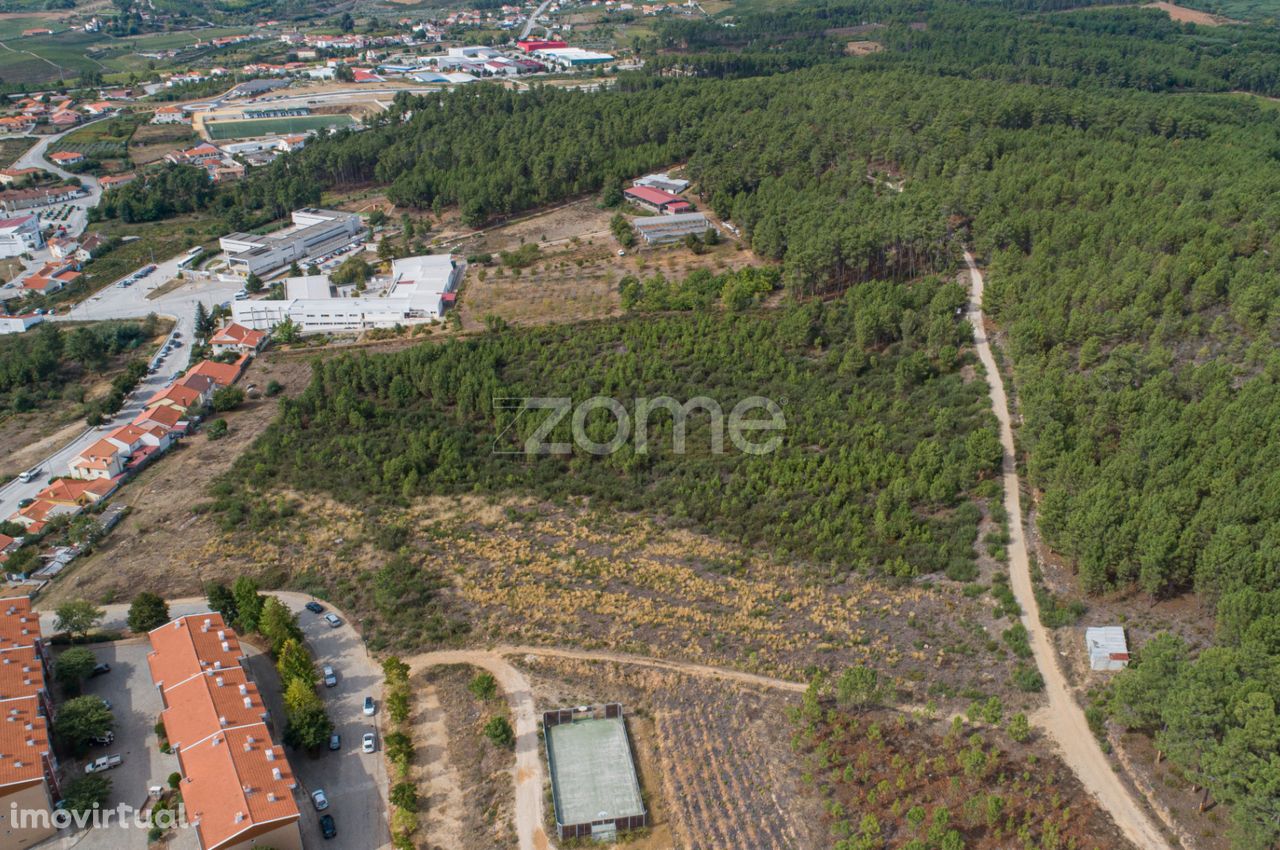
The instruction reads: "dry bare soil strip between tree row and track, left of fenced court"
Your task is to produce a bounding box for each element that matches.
[413,664,516,850]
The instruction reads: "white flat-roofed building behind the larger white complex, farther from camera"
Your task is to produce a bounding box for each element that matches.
[218,207,365,277]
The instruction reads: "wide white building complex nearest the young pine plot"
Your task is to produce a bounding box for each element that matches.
[232,253,465,333]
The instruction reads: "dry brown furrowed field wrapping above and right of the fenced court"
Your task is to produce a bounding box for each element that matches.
[521,657,823,850]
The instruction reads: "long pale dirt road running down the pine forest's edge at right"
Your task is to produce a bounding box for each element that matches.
[964,251,1170,850]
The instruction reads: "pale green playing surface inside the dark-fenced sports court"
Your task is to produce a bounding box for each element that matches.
[547,717,644,824]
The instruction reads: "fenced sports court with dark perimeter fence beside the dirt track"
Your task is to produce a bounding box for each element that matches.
[543,703,649,841]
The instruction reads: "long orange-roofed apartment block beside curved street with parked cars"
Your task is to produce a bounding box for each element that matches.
[147,612,302,850]
